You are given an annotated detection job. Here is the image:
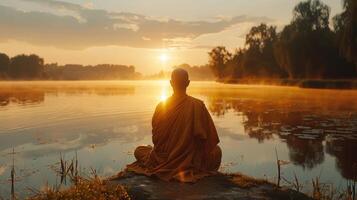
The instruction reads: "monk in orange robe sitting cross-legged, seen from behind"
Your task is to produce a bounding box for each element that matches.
[127,68,222,182]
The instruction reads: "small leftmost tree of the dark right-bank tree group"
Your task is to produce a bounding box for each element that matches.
[208,46,232,79]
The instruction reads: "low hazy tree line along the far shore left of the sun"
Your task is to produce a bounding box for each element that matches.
[0,53,141,80]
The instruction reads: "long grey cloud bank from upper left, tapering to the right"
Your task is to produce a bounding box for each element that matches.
[0,0,270,49]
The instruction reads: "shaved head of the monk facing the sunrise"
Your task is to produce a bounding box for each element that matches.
[170,68,190,93]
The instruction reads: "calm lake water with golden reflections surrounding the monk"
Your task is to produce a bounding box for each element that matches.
[0,81,357,198]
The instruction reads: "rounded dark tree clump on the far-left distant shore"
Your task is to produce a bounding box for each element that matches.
[8,54,44,79]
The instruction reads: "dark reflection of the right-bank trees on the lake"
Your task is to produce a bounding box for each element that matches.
[203,88,357,179]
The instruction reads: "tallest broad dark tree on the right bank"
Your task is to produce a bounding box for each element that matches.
[274,0,355,79]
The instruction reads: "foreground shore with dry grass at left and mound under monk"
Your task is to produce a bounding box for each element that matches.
[28,171,312,200]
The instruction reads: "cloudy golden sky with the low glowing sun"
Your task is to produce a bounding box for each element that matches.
[0,0,342,74]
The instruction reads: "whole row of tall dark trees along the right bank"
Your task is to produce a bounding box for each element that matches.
[209,0,357,81]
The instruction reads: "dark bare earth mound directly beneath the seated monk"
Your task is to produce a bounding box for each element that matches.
[110,172,311,200]
